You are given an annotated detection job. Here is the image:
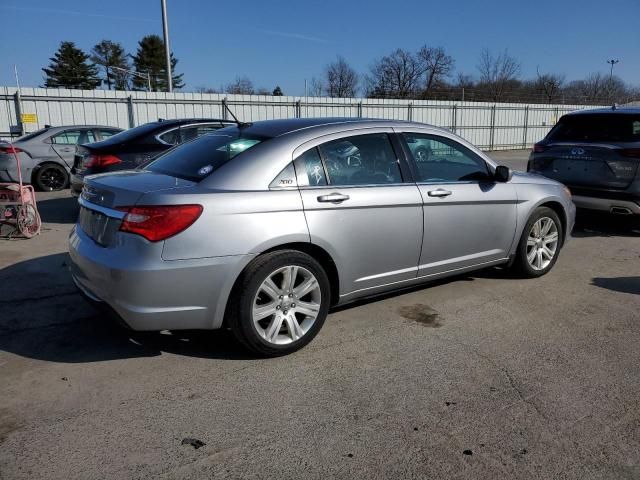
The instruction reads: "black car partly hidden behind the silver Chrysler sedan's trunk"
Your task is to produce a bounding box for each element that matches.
[71,118,234,196]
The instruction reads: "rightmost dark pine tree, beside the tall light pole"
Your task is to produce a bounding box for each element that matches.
[131,35,184,92]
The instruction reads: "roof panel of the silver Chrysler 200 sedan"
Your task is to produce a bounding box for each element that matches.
[234,117,441,138]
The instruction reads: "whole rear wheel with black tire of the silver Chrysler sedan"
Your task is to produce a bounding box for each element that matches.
[227,250,330,356]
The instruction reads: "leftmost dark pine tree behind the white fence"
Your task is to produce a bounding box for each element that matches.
[42,42,100,90]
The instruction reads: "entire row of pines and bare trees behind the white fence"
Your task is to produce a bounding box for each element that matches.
[43,40,640,104]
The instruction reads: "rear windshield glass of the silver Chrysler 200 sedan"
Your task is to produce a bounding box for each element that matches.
[144,128,268,182]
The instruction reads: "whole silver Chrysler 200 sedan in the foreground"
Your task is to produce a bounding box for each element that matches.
[69,118,575,356]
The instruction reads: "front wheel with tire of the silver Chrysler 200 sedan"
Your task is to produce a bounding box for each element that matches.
[514,207,563,278]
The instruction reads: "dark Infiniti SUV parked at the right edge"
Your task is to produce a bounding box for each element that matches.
[527,107,640,215]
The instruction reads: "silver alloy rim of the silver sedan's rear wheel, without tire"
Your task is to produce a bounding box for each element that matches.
[251,265,322,345]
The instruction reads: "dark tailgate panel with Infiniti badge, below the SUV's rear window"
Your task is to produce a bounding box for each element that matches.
[533,143,640,189]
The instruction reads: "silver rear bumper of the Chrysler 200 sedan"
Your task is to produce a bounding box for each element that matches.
[69,226,252,330]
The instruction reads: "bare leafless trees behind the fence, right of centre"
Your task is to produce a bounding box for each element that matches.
[307,45,640,104]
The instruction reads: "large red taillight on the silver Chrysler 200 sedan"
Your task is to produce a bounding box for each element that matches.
[118,205,202,242]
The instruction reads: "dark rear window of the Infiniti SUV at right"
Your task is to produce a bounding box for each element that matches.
[548,114,640,142]
